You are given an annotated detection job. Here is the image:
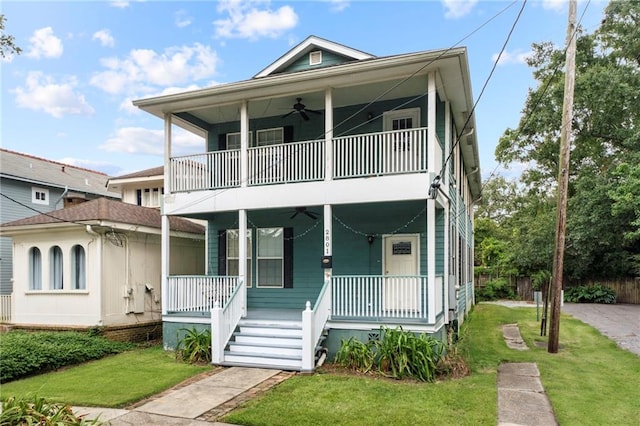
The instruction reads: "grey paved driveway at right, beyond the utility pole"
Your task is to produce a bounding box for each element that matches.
[562,303,640,356]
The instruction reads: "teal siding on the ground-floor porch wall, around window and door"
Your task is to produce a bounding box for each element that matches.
[208,201,430,310]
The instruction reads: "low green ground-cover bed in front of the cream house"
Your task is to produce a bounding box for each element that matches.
[0,330,133,383]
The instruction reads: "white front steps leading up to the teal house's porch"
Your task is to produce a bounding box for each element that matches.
[224,319,302,371]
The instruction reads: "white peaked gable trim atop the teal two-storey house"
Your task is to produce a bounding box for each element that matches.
[254,36,375,78]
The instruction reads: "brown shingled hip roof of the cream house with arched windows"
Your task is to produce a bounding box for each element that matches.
[0,198,204,234]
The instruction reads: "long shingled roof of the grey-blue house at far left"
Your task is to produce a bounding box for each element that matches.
[0,148,120,198]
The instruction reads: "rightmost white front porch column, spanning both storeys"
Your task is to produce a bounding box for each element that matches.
[427,72,440,324]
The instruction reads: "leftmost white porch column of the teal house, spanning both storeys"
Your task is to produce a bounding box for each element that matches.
[160,113,173,315]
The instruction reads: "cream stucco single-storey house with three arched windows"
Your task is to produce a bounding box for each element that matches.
[0,198,205,340]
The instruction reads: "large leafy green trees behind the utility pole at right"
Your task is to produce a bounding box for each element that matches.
[476,1,640,280]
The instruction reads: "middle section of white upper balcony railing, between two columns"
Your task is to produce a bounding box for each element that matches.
[248,140,325,185]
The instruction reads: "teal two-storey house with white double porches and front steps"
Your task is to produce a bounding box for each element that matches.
[134,36,481,371]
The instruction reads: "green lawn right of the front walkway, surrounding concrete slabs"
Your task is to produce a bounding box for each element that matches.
[223,304,640,426]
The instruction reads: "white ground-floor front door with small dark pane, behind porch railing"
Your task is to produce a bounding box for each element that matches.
[383,234,420,314]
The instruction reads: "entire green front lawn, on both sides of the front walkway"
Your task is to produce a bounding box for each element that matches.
[0,304,640,426]
